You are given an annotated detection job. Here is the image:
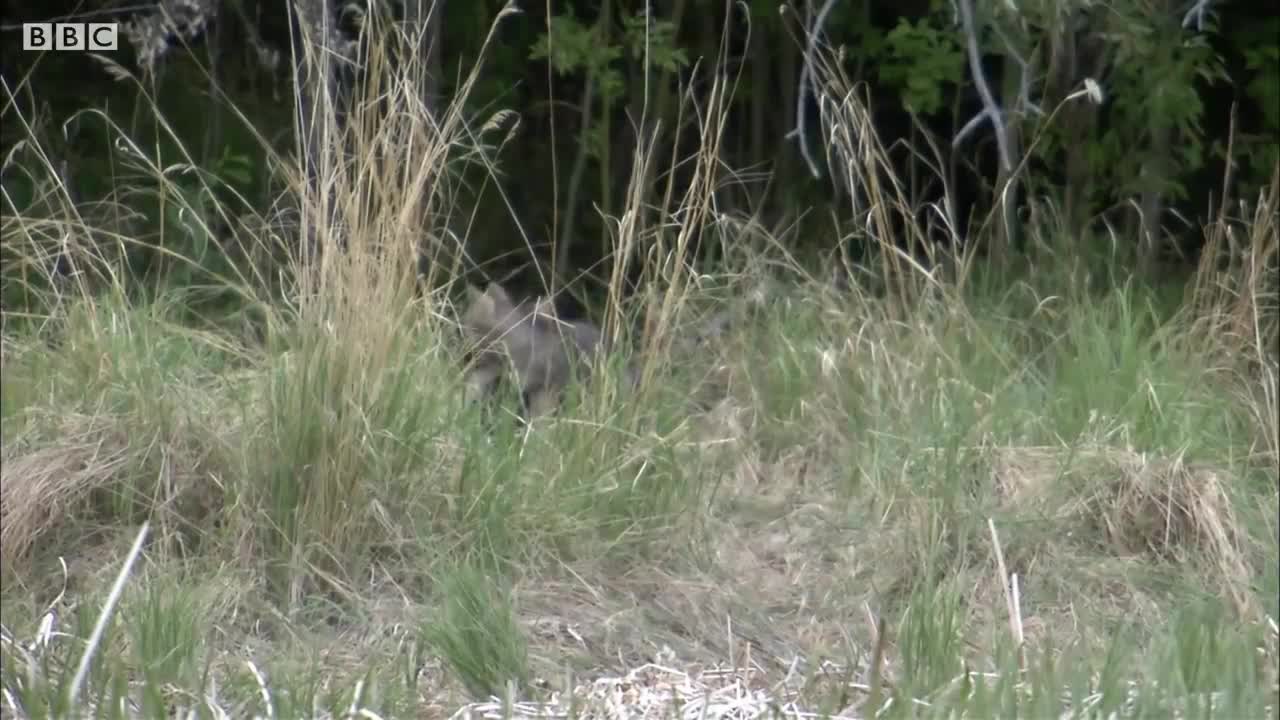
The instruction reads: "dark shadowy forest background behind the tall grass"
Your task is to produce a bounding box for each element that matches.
[0,0,1280,302]
